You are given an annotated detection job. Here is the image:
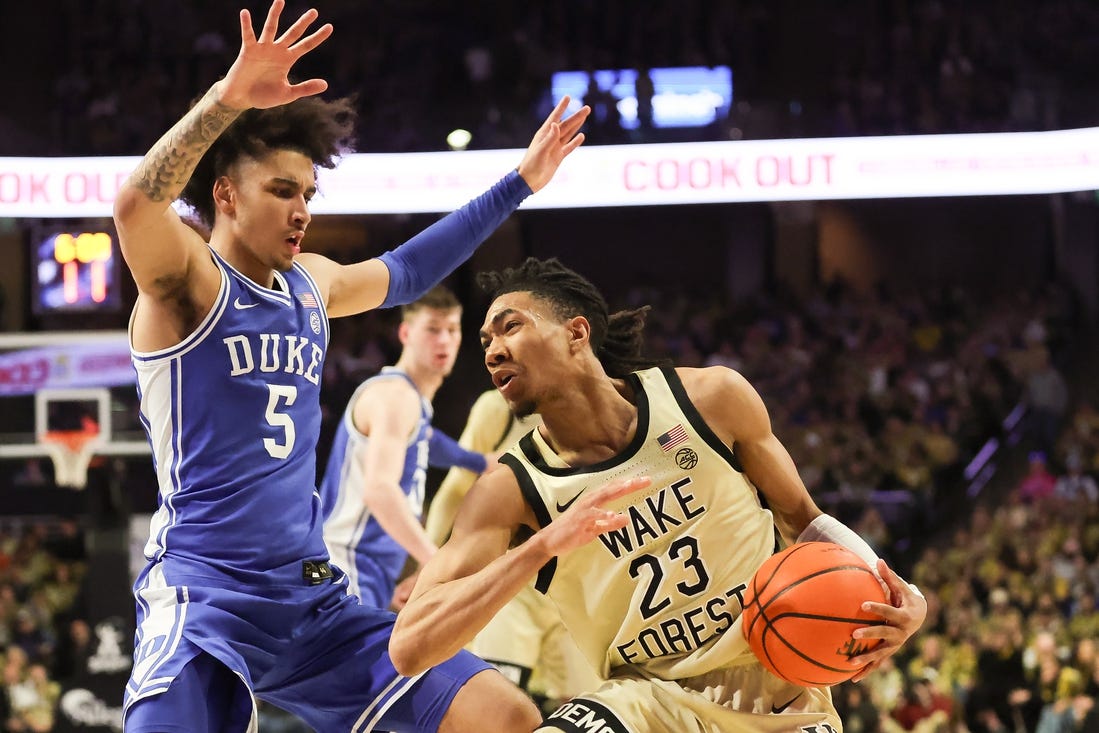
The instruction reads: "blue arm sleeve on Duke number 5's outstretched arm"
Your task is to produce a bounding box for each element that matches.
[379,170,531,308]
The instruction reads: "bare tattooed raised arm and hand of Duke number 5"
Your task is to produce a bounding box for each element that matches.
[114,0,332,298]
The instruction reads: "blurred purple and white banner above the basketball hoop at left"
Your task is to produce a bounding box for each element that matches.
[0,333,136,397]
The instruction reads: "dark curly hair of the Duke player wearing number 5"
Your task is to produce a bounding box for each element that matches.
[179,97,356,226]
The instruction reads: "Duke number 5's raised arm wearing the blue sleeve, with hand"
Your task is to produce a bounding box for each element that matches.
[299,98,591,318]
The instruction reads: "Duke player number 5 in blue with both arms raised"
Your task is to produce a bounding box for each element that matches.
[114,0,587,733]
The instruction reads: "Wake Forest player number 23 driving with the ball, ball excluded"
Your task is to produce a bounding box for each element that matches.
[389,259,926,733]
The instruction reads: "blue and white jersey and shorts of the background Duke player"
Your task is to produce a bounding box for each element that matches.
[321,367,432,608]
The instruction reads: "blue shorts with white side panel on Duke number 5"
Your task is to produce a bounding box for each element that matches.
[124,563,491,733]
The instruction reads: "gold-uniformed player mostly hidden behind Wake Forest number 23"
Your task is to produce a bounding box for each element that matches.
[422,389,600,708]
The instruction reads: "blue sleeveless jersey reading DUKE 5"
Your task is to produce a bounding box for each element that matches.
[133,253,329,585]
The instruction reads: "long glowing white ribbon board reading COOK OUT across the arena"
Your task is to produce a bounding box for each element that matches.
[0,127,1099,218]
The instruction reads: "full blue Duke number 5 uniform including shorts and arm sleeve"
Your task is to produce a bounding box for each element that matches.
[124,171,530,733]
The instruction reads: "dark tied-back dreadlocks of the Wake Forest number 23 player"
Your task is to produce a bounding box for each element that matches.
[477,257,669,378]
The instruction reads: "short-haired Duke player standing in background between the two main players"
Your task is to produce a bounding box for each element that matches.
[320,285,496,608]
